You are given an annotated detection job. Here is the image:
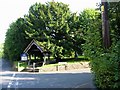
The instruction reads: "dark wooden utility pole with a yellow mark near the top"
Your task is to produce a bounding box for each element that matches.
[101,0,110,49]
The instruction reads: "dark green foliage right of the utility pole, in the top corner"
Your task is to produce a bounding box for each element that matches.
[108,2,120,40]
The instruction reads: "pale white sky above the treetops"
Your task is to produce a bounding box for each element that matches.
[0,0,100,43]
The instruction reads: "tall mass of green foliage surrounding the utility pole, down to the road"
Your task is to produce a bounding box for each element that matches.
[83,2,120,90]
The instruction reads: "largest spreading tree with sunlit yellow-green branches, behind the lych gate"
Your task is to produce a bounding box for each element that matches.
[25,2,81,58]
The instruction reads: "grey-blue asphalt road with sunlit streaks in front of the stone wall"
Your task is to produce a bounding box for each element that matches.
[0,60,96,90]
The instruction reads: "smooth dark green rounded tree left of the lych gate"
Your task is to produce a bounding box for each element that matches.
[4,18,29,61]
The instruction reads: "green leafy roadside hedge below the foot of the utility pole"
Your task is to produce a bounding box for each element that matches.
[91,41,120,88]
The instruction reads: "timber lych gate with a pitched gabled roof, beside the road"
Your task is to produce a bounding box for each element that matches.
[24,40,50,66]
